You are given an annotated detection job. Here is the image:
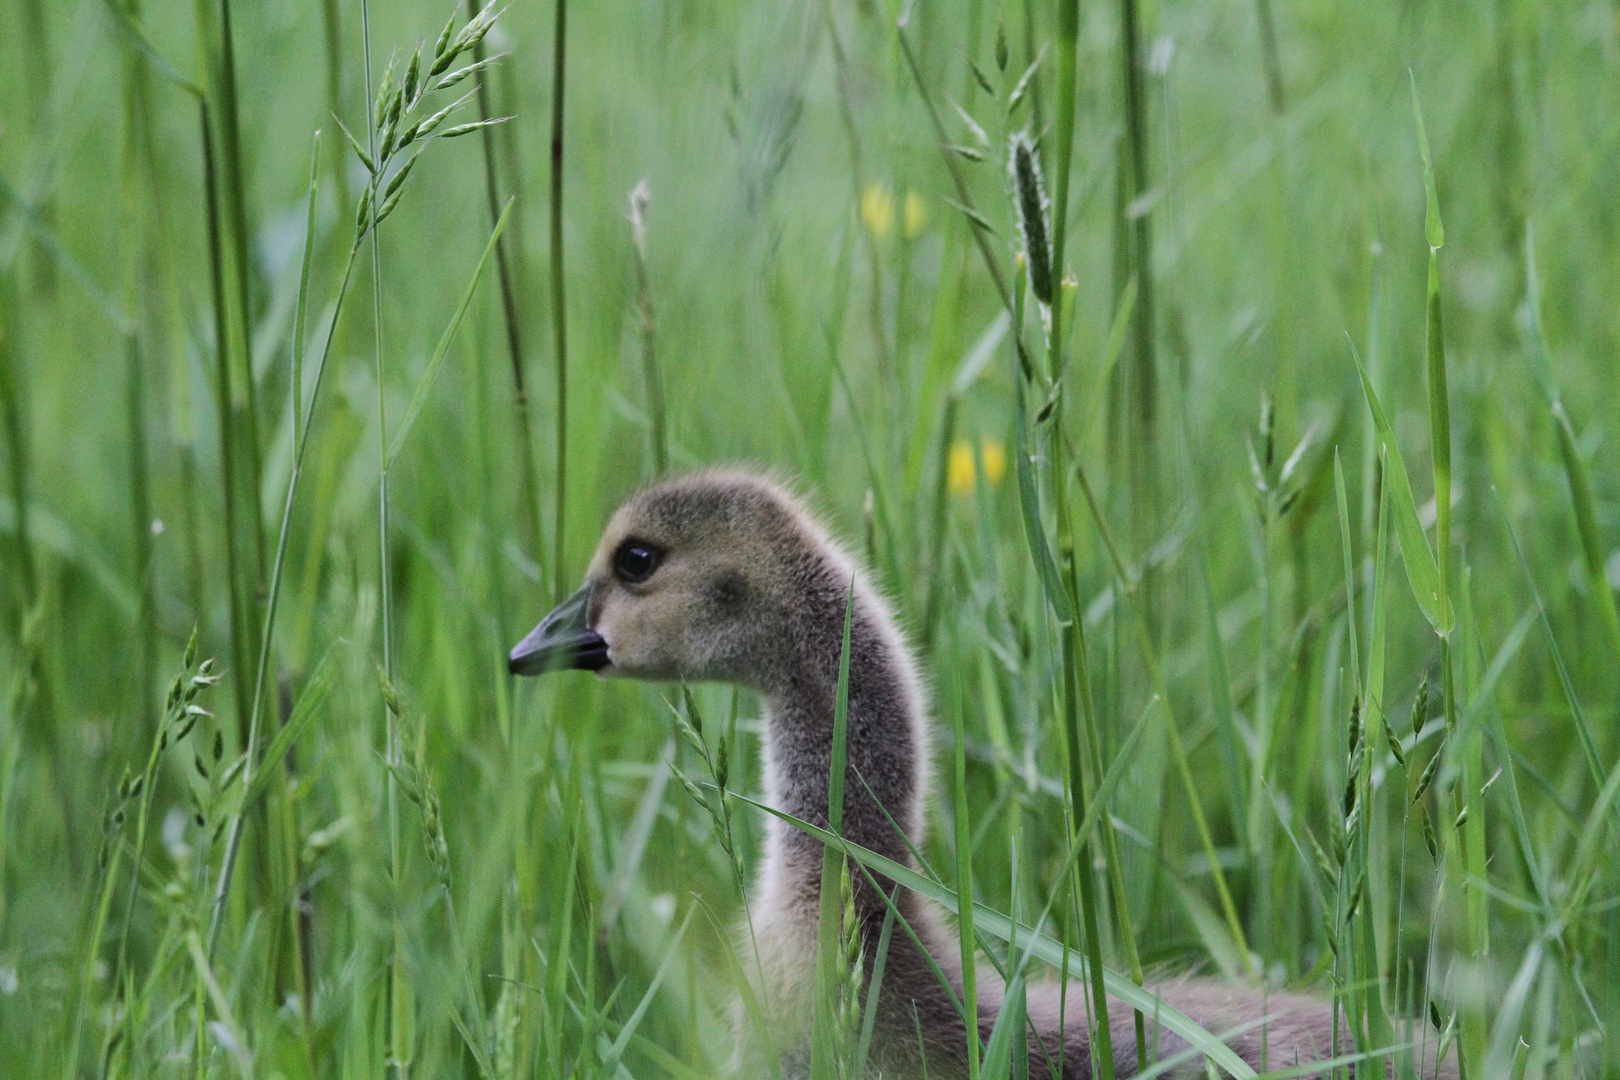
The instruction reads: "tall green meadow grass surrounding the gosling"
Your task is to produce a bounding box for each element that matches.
[0,0,1620,1080]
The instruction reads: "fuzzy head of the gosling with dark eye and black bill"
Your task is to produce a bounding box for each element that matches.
[509,471,852,690]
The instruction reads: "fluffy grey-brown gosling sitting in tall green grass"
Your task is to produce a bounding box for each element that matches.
[510,471,1445,1080]
